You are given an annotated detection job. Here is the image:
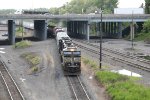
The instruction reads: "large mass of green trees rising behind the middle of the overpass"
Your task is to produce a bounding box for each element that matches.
[50,0,118,14]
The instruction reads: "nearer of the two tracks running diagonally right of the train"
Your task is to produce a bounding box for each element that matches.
[74,39,150,72]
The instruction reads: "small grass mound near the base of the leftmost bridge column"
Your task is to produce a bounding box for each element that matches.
[13,40,32,48]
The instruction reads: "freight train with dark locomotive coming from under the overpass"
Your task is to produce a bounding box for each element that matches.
[54,28,81,75]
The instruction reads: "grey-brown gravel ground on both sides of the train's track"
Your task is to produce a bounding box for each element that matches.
[0,39,108,100]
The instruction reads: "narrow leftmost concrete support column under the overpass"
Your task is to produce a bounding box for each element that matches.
[8,20,15,45]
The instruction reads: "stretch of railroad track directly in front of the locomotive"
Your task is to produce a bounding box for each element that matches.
[67,76,91,100]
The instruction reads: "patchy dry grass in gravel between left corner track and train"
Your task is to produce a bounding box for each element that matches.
[21,53,41,72]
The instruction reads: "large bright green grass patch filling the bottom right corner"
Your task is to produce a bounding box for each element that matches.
[96,71,150,100]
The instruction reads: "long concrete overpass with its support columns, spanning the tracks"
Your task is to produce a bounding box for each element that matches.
[0,14,150,44]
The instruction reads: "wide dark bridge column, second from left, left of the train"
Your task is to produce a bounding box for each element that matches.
[34,20,47,40]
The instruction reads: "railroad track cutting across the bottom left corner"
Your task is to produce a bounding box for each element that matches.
[0,61,25,100]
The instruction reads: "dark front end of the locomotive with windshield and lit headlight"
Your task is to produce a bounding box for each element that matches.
[62,47,81,75]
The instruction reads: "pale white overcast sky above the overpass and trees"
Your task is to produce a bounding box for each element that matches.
[0,0,144,9]
